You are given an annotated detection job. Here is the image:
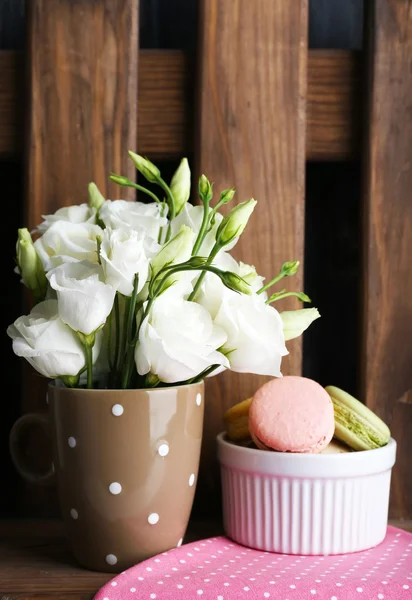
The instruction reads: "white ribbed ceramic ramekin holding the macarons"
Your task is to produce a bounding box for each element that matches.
[218,433,396,555]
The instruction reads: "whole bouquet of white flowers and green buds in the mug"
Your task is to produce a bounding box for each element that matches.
[7,152,319,389]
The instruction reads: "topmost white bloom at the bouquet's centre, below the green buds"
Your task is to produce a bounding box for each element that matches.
[99,200,167,241]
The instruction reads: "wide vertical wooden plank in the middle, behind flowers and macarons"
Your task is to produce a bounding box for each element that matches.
[195,0,308,508]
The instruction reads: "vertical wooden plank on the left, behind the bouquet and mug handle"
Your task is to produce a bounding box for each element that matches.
[22,0,139,515]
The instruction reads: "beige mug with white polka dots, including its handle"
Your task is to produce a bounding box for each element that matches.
[10,383,204,572]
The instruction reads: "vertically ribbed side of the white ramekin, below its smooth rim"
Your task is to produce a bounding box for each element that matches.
[222,465,391,555]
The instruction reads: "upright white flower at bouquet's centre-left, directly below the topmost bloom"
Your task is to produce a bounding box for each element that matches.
[100,227,155,296]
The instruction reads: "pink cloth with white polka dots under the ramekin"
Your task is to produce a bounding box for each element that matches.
[95,527,412,600]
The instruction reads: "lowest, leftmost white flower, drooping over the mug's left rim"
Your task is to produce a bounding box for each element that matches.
[7,300,100,379]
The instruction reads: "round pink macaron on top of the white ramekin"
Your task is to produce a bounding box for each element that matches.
[249,376,335,454]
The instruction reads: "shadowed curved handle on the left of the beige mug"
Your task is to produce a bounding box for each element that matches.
[9,413,55,485]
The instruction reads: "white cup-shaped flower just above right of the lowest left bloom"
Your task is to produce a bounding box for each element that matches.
[47,261,116,335]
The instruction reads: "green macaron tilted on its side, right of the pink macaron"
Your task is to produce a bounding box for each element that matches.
[325,385,391,450]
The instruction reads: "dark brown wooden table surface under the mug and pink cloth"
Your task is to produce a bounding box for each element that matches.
[0,520,412,600]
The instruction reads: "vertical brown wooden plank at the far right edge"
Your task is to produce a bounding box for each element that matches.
[361,0,412,519]
